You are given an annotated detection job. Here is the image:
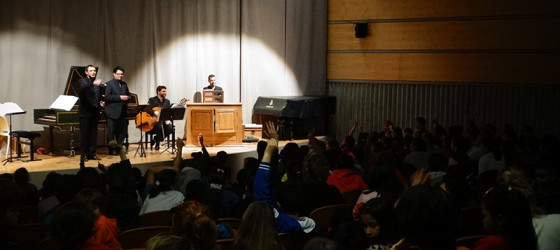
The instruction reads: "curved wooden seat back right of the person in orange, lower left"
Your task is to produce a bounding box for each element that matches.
[118,226,171,249]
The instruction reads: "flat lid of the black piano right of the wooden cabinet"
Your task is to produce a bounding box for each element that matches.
[253,96,336,118]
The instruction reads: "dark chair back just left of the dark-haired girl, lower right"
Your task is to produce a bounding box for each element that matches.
[457,206,484,237]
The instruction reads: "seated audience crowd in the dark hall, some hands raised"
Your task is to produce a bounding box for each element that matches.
[0,117,560,250]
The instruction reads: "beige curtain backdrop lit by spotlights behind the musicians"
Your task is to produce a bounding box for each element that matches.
[0,0,328,141]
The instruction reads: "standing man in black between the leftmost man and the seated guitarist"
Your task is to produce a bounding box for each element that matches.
[105,66,131,154]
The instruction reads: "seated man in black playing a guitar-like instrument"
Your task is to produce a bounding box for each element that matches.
[148,85,173,150]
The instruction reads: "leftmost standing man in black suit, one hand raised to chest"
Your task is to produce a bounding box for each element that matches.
[78,64,104,168]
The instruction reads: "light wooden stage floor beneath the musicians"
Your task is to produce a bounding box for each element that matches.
[0,140,307,188]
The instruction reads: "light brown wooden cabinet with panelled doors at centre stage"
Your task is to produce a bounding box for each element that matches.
[185,103,243,146]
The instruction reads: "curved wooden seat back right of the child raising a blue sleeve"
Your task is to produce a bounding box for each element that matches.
[309,204,354,237]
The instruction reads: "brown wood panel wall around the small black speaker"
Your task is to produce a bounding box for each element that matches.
[327,0,560,84]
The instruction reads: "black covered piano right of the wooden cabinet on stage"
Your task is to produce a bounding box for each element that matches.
[252,96,336,140]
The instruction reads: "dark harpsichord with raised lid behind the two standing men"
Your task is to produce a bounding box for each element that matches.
[33,66,138,151]
